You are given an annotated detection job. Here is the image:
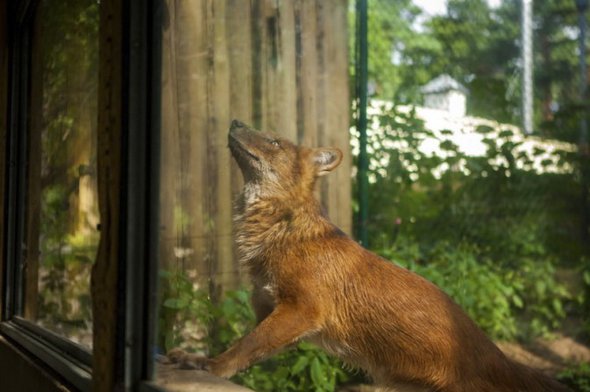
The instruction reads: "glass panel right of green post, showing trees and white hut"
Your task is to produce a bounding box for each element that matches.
[353,0,590,390]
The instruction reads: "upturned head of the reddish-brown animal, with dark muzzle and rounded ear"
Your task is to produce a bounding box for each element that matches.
[229,120,342,196]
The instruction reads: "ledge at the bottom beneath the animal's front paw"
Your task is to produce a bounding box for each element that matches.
[156,364,251,392]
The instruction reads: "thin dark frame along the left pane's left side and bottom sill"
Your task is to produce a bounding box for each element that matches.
[0,0,91,390]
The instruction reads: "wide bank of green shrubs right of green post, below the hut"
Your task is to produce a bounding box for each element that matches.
[360,106,584,339]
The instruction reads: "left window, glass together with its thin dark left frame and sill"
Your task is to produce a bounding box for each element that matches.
[0,0,100,389]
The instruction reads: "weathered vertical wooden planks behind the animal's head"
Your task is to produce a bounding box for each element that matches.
[161,0,351,287]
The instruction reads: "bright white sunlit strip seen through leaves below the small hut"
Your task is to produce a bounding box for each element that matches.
[350,100,576,182]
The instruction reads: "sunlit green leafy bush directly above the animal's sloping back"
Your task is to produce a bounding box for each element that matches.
[379,239,569,340]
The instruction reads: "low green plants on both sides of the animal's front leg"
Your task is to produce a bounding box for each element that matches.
[159,271,352,392]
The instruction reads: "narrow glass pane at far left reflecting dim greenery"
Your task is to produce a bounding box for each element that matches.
[23,0,99,347]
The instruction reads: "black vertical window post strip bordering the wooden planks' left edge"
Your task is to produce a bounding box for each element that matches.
[121,0,163,391]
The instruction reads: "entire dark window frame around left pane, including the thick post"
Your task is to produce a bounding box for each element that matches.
[0,0,162,391]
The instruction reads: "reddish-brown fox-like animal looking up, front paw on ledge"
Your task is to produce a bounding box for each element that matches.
[168,120,569,392]
